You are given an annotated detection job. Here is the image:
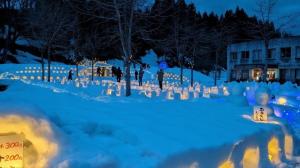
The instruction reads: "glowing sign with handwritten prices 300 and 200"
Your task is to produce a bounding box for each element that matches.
[0,135,23,168]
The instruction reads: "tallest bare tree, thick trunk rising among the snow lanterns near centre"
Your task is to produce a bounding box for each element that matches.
[69,0,146,96]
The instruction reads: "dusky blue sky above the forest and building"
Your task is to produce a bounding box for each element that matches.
[186,0,300,35]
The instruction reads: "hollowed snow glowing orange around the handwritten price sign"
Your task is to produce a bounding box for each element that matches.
[0,115,58,167]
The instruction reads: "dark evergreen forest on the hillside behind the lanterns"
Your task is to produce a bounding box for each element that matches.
[0,0,282,70]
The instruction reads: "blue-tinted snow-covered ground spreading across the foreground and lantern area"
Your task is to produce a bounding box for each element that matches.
[0,64,300,168]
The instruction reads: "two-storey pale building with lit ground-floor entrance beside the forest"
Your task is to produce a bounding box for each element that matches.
[227,37,300,84]
